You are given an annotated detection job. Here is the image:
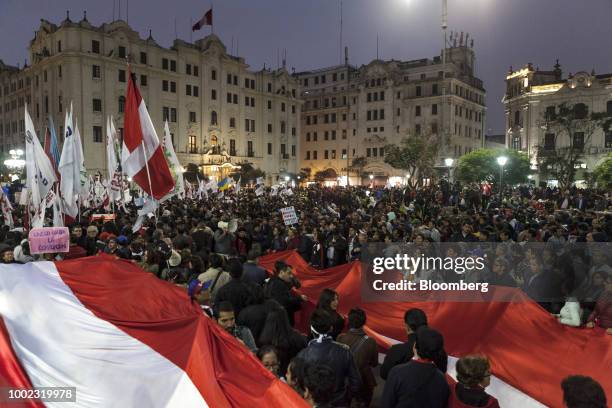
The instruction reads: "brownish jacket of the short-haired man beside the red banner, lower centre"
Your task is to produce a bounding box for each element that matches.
[338,329,378,394]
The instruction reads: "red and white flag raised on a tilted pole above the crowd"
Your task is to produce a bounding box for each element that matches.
[121,69,174,200]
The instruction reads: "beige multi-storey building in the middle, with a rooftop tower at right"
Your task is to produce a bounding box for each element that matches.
[296,40,486,184]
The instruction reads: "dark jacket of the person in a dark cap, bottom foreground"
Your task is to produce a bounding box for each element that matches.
[382,360,450,408]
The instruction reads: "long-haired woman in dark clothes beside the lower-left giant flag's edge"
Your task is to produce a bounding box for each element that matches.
[257,309,307,376]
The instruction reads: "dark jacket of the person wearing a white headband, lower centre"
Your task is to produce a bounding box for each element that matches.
[297,337,361,407]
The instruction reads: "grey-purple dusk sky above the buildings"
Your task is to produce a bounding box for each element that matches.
[0,0,612,133]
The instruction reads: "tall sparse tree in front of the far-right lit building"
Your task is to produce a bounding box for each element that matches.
[537,103,612,189]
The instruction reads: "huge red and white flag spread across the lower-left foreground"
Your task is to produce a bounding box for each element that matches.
[0,255,308,408]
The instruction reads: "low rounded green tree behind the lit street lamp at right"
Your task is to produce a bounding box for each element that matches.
[455,149,530,184]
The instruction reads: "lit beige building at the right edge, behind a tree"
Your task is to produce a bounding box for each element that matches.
[503,61,612,185]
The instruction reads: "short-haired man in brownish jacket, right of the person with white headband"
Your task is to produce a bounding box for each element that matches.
[337,308,378,407]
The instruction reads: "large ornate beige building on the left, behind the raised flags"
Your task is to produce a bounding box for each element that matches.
[0,17,301,183]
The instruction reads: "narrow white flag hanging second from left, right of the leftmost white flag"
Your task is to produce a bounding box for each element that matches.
[58,104,81,218]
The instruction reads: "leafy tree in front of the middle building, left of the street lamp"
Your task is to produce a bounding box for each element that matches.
[385,135,439,188]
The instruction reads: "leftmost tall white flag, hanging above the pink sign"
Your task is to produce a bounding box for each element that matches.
[25,105,57,210]
